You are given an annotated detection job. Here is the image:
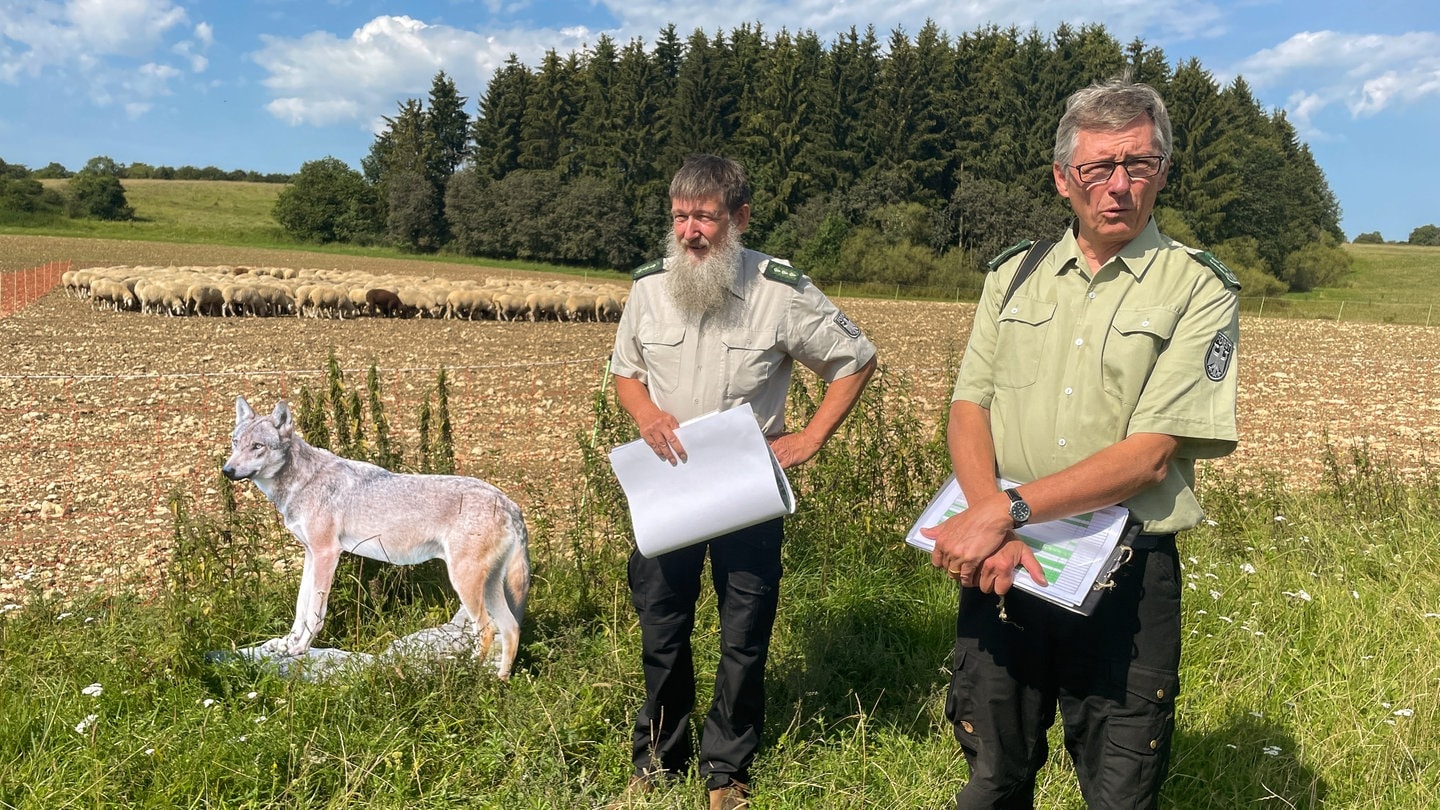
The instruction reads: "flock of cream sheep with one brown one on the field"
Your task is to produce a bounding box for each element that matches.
[62,259,629,321]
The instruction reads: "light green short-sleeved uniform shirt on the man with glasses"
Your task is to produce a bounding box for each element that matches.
[953,221,1240,533]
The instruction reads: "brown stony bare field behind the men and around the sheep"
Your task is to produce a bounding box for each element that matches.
[0,236,1440,604]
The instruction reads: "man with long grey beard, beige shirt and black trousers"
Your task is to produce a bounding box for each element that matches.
[611,156,876,810]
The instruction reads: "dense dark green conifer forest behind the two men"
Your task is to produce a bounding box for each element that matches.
[275,23,1348,294]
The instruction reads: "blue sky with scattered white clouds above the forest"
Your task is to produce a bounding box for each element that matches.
[0,0,1440,241]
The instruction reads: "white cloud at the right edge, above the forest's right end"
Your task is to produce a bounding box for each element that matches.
[1233,30,1440,137]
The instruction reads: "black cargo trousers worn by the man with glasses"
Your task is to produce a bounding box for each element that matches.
[945,535,1182,810]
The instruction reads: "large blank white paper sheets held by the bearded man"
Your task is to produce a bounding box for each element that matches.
[611,402,795,558]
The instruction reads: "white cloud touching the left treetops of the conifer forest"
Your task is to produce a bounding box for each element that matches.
[251,16,590,127]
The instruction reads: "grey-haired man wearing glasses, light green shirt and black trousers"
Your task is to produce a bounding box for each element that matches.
[929,72,1238,809]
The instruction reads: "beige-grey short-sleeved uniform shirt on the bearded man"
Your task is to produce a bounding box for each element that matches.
[611,251,876,435]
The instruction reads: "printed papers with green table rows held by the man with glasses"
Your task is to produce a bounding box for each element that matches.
[904,476,1130,615]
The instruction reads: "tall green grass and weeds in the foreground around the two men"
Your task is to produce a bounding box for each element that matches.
[0,375,1440,810]
